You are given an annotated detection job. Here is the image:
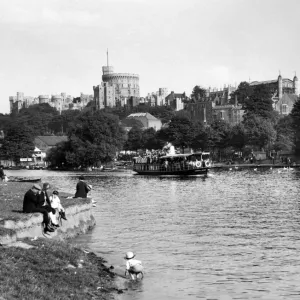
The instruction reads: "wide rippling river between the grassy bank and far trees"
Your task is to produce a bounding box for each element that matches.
[7,169,300,300]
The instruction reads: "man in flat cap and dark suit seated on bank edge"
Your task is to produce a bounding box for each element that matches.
[23,184,54,233]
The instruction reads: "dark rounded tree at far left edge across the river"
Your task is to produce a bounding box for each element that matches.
[0,123,34,164]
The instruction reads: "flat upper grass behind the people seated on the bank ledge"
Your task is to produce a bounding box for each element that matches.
[0,182,90,223]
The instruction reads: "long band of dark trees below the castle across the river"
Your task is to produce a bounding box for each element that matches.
[0,82,300,167]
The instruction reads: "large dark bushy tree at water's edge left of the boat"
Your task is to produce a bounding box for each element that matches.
[48,111,125,167]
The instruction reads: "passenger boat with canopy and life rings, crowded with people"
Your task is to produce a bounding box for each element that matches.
[133,152,211,176]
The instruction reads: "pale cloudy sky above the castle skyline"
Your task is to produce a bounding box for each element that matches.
[0,0,300,113]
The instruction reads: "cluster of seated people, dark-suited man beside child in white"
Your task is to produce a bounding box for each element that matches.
[23,182,67,233]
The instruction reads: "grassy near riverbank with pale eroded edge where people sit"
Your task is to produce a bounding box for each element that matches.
[0,182,122,300]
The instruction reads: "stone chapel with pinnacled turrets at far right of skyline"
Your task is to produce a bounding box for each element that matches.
[250,74,299,116]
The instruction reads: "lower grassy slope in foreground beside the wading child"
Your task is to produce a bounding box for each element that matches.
[0,239,122,300]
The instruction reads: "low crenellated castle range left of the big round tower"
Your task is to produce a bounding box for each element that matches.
[9,92,93,113]
